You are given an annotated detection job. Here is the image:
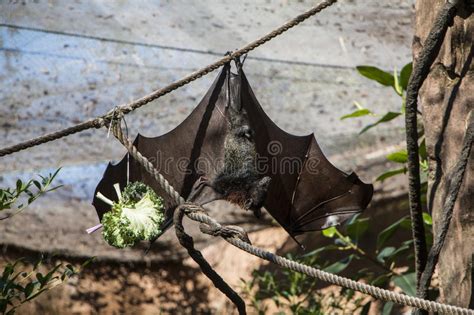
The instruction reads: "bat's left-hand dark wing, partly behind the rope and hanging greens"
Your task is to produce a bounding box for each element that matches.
[93,66,228,220]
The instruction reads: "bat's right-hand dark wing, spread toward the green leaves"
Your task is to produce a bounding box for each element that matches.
[241,72,373,242]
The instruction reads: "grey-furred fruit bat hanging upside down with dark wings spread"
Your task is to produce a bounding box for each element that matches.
[93,60,373,247]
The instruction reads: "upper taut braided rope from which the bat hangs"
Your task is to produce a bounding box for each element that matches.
[0,0,337,157]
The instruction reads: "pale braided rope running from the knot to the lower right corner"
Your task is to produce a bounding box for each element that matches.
[187,211,474,315]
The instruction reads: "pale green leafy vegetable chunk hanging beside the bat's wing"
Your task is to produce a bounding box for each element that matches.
[97,182,165,248]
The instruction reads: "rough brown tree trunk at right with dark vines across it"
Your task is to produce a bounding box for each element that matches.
[413,0,474,307]
